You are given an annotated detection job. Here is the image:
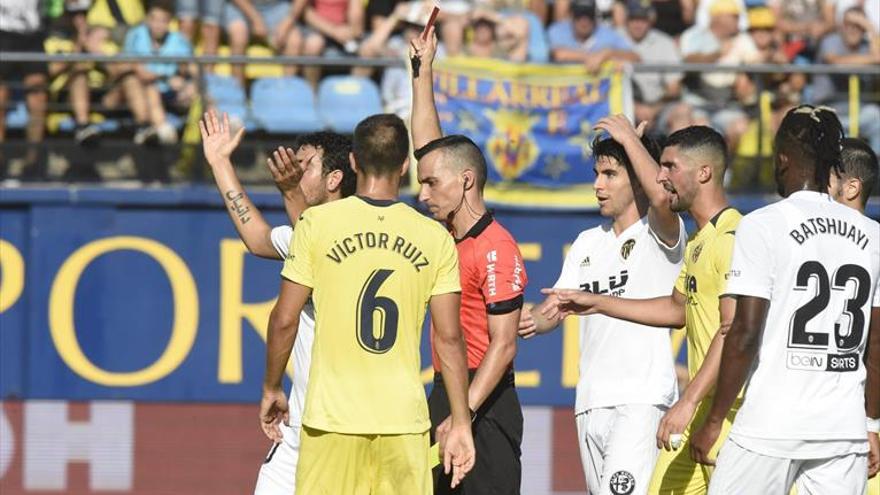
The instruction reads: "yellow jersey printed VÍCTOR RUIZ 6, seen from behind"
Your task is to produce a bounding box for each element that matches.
[281,197,461,434]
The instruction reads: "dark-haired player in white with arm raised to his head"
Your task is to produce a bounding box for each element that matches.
[520,117,686,495]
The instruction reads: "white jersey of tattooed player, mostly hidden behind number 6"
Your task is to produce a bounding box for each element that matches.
[271,225,315,427]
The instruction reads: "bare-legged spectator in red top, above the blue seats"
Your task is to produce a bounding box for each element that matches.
[293,0,369,87]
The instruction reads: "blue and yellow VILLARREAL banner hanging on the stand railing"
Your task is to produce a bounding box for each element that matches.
[434,58,632,206]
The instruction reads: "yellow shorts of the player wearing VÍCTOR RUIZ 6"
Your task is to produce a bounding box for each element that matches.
[296,426,432,495]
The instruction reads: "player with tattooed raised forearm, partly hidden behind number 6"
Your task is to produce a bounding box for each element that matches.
[199,111,356,495]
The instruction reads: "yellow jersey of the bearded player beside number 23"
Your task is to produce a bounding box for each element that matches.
[675,208,742,379]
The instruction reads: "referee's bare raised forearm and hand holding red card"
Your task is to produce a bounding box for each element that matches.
[410,26,443,149]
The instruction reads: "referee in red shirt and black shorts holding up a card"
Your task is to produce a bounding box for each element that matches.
[412,30,527,495]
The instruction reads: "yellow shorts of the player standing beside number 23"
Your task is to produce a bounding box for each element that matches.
[648,399,740,495]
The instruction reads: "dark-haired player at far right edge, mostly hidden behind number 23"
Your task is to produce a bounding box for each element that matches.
[828,138,880,495]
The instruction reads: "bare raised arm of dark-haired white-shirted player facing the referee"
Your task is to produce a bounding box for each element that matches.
[596,115,681,246]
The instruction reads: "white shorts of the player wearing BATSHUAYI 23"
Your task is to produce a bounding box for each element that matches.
[709,438,868,495]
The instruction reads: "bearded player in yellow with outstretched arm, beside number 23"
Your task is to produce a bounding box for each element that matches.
[544,121,742,495]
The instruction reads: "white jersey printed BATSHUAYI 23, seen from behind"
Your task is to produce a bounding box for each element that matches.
[726,191,880,446]
